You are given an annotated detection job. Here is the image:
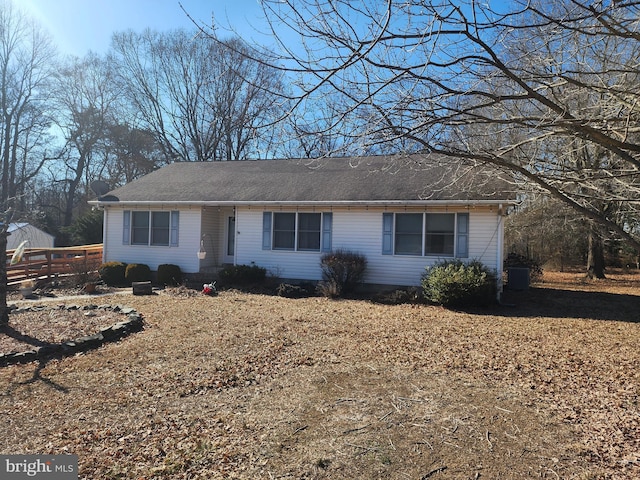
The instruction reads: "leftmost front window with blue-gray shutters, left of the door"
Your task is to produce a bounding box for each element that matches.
[122,210,179,247]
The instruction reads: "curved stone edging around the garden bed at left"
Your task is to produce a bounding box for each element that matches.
[0,305,143,367]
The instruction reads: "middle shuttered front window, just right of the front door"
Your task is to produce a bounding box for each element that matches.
[262,212,332,252]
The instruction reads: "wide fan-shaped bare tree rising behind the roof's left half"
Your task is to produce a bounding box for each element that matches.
[112,30,281,161]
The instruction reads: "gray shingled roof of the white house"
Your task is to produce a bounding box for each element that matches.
[94,155,515,204]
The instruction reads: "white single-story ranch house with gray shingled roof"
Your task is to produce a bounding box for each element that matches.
[91,154,516,287]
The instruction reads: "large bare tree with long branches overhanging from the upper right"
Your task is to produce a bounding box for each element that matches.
[205,0,640,278]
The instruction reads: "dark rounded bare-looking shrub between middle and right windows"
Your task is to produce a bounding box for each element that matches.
[318,250,367,297]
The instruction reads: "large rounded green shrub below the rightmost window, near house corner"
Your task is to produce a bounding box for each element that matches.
[422,260,497,307]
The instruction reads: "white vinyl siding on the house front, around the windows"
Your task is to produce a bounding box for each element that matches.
[104,205,502,285]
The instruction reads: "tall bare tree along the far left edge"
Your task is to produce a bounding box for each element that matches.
[0,1,55,328]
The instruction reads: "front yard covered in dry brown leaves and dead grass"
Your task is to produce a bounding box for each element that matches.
[0,273,640,480]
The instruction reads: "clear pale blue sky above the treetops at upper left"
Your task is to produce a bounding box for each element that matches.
[21,0,263,56]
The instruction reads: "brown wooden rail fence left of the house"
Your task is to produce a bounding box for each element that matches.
[7,243,102,286]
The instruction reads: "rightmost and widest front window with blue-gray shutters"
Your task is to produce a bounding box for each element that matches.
[382,213,469,258]
